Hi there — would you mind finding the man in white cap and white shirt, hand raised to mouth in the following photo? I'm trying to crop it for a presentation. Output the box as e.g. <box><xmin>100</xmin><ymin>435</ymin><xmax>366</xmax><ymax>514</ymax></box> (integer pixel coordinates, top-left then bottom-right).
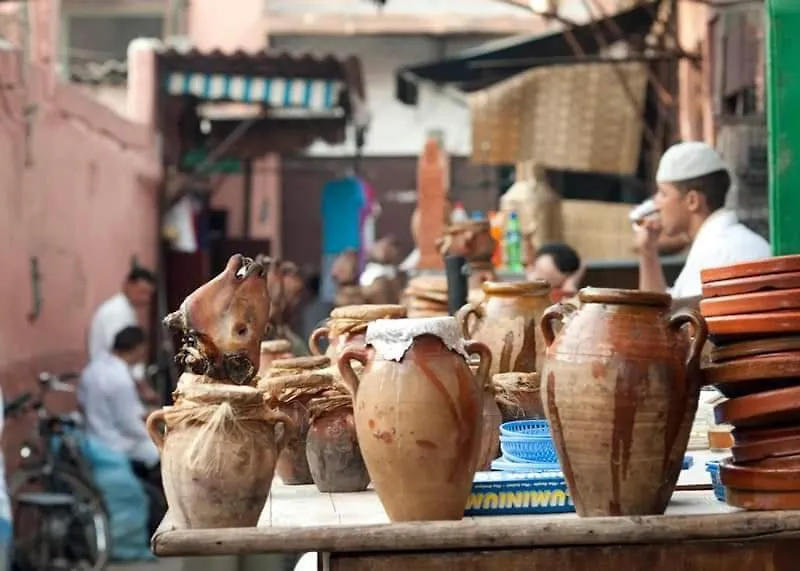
<box><xmin>636</xmin><ymin>141</ymin><xmax>772</xmax><ymax>302</ymax></box>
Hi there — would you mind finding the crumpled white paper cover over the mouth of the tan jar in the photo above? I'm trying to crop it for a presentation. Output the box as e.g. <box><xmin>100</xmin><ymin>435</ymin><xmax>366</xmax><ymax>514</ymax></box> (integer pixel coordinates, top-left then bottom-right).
<box><xmin>366</xmin><ymin>316</ymin><xmax>469</xmax><ymax>361</ymax></box>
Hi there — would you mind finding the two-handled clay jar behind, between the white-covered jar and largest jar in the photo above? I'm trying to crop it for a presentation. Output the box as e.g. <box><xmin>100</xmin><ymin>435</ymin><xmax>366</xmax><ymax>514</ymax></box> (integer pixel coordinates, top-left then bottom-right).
<box><xmin>456</xmin><ymin>281</ymin><xmax>552</xmax><ymax>375</ymax></box>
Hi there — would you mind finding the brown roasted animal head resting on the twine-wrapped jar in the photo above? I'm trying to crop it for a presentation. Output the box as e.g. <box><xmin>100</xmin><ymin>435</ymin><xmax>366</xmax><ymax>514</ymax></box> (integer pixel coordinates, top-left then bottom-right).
<box><xmin>164</xmin><ymin>254</ymin><xmax>276</xmax><ymax>385</ymax></box>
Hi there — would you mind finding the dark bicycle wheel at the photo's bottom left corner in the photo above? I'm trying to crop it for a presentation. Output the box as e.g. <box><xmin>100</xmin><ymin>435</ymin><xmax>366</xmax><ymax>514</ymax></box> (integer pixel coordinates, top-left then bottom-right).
<box><xmin>9</xmin><ymin>470</ymin><xmax>111</xmax><ymax>571</ymax></box>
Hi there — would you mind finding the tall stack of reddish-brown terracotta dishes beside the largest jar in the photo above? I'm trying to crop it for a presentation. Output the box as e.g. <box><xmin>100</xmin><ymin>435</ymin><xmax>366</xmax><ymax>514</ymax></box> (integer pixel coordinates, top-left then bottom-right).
<box><xmin>700</xmin><ymin>256</ymin><xmax>800</xmax><ymax>509</ymax></box>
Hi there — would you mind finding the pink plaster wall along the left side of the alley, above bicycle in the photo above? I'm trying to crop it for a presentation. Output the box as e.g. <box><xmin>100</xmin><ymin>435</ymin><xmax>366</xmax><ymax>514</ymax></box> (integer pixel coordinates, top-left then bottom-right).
<box><xmin>0</xmin><ymin>51</ymin><xmax>159</xmax><ymax>465</ymax></box>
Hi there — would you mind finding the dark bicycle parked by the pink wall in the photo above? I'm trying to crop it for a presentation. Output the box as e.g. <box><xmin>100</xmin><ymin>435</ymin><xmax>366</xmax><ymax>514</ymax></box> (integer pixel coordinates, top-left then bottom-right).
<box><xmin>4</xmin><ymin>373</ymin><xmax>111</xmax><ymax>571</ymax></box>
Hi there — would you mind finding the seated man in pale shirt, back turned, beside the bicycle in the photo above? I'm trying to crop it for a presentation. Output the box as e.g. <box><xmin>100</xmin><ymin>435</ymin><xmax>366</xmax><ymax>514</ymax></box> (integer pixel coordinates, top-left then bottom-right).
<box><xmin>78</xmin><ymin>326</ymin><xmax>164</xmax><ymax>532</ymax></box>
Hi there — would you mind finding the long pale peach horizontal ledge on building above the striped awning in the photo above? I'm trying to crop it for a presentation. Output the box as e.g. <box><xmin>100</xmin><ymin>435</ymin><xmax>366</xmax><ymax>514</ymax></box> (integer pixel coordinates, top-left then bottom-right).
<box><xmin>264</xmin><ymin>12</ymin><xmax>549</xmax><ymax>36</ymax></box>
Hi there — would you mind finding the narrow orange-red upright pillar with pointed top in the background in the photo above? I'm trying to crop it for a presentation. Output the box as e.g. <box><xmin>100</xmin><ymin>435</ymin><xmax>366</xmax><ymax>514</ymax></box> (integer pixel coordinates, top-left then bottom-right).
<box><xmin>417</xmin><ymin>133</ymin><xmax>450</xmax><ymax>270</ymax></box>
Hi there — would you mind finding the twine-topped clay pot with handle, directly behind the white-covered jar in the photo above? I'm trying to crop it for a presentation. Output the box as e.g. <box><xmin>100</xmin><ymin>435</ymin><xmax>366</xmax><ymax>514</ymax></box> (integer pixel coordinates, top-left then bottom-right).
<box><xmin>308</xmin><ymin>305</ymin><xmax>406</xmax><ymax>360</ymax></box>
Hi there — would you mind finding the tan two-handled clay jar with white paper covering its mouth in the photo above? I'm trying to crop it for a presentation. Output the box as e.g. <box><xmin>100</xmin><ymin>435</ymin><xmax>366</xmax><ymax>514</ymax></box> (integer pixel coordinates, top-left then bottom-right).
<box><xmin>339</xmin><ymin>317</ymin><xmax>491</xmax><ymax>521</ymax></box>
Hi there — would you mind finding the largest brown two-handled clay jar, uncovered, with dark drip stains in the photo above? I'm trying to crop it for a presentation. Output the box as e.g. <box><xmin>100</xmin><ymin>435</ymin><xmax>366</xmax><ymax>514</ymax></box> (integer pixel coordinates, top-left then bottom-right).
<box><xmin>541</xmin><ymin>288</ymin><xmax>707</xmax><ymax>516</ymax></box>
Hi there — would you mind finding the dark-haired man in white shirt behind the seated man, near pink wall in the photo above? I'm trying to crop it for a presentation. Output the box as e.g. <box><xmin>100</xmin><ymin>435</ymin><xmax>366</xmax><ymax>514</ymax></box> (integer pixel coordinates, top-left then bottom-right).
<box><xmin>89</xmin><ymin>268</ymin><xmax>156</xmax><ymax>361</ymax></box>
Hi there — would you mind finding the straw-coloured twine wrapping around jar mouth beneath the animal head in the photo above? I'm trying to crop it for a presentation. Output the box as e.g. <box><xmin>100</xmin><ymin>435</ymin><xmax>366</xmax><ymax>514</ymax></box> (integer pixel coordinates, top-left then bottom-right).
<box><xmin>164</xmin><ymin>397</ymin><xmax>276</xmax><ymax>477</ymax></box>
